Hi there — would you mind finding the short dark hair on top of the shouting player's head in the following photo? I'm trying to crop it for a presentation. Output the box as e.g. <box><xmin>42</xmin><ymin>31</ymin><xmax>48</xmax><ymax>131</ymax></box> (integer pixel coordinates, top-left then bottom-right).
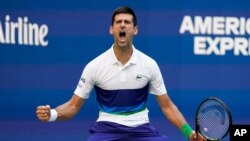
<box><xmin>111</xmin><ymin>6</ymin><xmax>137</xmax><ymax>26</ymax></box>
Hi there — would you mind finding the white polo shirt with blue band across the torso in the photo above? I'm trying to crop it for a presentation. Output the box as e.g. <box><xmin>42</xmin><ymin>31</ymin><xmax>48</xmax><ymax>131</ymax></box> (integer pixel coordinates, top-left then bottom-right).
<box><xmin>74</xmin><ymin>46</ymin><xmax>167</xmax><ymax>127</ymax></box>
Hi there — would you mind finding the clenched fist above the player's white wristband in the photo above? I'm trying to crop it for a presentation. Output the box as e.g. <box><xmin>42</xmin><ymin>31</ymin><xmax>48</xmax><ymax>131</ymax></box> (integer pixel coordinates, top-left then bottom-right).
<box><xmin>36</xmin><ymin>105</ymin><xmax>51</xmax><ymax>122</ymax></box>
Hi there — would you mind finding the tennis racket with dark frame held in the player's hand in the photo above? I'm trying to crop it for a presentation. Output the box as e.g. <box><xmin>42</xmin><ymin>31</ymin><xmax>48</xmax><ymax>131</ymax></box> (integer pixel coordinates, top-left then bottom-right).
<box><xmin>195</xmin><ymin>97</ymin><xmax>232</xmax><ymax>141</ymax></box>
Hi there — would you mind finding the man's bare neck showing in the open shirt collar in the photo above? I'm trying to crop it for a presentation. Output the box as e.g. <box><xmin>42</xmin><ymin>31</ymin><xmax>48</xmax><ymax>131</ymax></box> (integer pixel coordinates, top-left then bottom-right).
<box><xmin>113</xmin><ymin>45</ymin><xmax>133</xmax><ymax>65</ymax></box>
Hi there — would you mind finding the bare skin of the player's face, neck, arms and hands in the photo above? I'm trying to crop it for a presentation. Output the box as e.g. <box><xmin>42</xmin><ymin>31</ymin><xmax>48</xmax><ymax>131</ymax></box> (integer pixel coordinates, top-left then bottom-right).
<box><xmin>36</xmin><ymin>13</ymin><xmax>205</xmax><ymax>141</ymax></box>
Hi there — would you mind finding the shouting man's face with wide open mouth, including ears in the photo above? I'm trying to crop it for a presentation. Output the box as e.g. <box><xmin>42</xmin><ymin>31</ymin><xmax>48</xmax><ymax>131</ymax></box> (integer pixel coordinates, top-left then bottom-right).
<box><xmin>110</xmin><ymin>13</ymin><xmax>138</xmax><ymax>47</ymax></box>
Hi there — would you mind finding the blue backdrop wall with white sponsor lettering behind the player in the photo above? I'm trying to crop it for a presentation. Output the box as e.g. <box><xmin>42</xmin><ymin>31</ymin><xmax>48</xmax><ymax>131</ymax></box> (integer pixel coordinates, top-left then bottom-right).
<box><xmin>0</xmin><ymin>0</ymin><xmax>250</xmax><ymax>141</ymax></box>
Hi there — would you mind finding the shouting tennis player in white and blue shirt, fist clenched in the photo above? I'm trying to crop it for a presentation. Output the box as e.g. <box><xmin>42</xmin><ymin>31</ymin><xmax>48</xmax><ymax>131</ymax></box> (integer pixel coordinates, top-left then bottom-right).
<box><xmin>36</xmin><ymin>7</ymin><xmax>204</xmax><ymax>141</ymax></box>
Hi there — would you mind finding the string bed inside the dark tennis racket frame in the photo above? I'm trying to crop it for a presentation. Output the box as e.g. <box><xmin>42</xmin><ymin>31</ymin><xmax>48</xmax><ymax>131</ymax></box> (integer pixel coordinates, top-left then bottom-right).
<box><xmin>197</xmin><ymin>101</ymin><xmax>230</xmax><ymax>139</ymax></box>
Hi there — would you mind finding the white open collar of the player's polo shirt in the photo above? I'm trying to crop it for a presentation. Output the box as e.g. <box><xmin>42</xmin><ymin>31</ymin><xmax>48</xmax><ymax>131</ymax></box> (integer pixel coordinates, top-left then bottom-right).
<box><xmin>109</xmin><ymin>45</ymin><xmax>138</xmax><ymax>64</ymax></box>
